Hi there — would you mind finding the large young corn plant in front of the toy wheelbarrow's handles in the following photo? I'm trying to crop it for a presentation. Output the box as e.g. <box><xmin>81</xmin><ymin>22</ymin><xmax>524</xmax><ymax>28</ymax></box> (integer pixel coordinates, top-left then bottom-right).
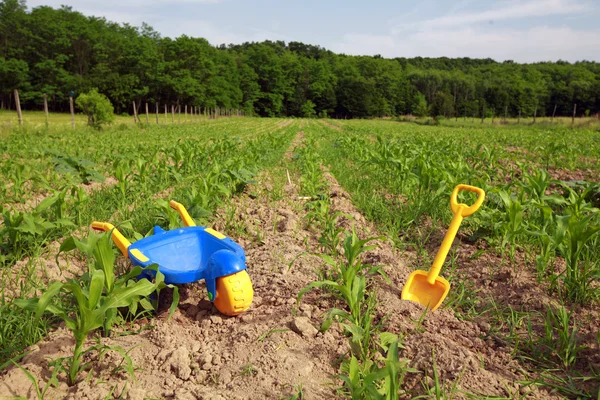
<box><xmin>16</xmin><ymin>234</ymin><xmax>179</xmax><ymax>385</ymax></box>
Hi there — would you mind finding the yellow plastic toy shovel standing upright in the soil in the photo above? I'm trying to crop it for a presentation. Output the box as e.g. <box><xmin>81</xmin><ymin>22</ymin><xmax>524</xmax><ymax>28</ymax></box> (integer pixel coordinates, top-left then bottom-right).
<box><xmin>402</xmin><ymin>185</ymin><xmax>485</xmax><ymax>311</ymax></box>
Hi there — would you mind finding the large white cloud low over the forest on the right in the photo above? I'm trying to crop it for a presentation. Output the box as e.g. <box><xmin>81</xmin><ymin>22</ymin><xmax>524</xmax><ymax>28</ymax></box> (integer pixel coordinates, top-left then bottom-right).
<box><xmin>332</xmin><ymin>0</ymin><xmax>600</xmax><ymax>62</ymax></box>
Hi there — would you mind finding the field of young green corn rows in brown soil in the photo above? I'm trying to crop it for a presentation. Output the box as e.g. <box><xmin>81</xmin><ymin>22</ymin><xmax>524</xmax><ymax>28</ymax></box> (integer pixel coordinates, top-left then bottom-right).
<box><xmin>0</xmin><ymin>113</ymin><xmax>600</xmax><ymax>399</ymax></box>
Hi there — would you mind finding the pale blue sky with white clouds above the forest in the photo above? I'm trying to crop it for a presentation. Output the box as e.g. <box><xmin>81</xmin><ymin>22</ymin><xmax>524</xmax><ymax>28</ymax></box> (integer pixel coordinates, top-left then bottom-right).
<box><xmin>27</xmin><ymin>0</ymin><xmax>600</xmax><ymax>62</ymax></box>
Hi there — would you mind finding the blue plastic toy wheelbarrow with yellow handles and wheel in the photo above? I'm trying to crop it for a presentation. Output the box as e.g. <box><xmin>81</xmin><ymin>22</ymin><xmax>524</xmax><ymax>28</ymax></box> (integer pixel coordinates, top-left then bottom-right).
<box><xmin>92</xmin><ymin>200</ymin><xmax>254</xmax><ymax>316</ymax></box>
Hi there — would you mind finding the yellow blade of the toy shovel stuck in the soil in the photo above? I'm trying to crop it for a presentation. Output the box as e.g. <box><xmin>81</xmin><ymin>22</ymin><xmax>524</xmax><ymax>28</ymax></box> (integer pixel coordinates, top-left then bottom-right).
<box><xmin>402</xmin><ymin>270</ymin><xmax>450</xmax><ymax>311</ymax></box>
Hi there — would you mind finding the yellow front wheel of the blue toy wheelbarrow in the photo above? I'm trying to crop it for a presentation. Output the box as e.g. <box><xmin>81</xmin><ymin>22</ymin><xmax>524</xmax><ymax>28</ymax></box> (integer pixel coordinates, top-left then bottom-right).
<box><xmin>214</xmin><ymin>270</ymin><xmax>254</xmax><ymax>317</ymax></box>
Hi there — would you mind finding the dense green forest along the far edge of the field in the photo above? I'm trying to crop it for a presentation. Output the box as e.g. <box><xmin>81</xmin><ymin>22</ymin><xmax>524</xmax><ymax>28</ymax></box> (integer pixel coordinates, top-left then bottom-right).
<box><xmin>0</xmin><ymin>0</ymin><xmax>600</xmax><ymax>118</ymax></box>
